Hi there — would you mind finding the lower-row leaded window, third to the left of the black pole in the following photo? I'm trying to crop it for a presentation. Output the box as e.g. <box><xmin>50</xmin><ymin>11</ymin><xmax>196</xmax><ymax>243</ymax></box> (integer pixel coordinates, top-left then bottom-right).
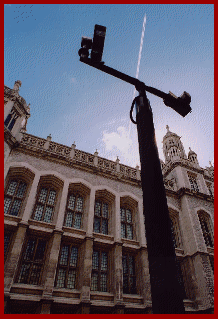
<box><xmin>56</xmin><ymin>244</ymin><xmax>78</xmax><ymax>289</ymax></box>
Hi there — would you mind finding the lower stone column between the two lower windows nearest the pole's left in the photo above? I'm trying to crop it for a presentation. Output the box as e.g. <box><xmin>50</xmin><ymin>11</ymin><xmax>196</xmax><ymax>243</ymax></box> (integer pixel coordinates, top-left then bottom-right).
<box><xmin>112</xmin><ymin>242</ymin><xmax>123</xmax><ymax>308</ymax></box>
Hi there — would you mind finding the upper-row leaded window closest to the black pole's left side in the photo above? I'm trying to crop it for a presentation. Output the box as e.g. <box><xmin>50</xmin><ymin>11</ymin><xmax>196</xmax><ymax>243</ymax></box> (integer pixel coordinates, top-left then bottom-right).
<box><xmin>120</xmin><ymin>207</ymin><xmax>133</xmax><ymax>239</ymax></box>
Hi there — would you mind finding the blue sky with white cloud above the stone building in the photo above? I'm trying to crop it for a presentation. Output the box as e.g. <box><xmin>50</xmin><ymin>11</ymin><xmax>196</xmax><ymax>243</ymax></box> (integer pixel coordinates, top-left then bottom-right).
<box><xmin>4</xmin><ymin>4</ymin><xmax>214</xmax><ymax>167</ymax></box>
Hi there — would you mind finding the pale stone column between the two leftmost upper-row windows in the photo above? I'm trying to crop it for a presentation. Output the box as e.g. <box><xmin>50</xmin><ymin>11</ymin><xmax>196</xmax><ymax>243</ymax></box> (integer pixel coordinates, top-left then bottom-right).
<box><xmin>22</xmin><ymin>172</ymin><xmax>40</xmax><ymax>222</ymax></box>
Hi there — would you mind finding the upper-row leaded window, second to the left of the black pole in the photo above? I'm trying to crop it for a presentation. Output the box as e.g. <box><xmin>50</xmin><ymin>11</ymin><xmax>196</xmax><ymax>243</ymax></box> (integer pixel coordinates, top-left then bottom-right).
<box><xmin>94</xmin><ymin>201</ymin><xmax>109</xmax><ymax>235</ymax></box>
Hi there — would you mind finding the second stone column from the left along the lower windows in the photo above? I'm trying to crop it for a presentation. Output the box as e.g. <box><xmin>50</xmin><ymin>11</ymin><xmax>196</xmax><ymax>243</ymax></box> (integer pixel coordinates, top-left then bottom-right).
<box><xmin>42</xmin><ymin>229</ymin><xmax>63</xmax><ymax>304</ymax></box>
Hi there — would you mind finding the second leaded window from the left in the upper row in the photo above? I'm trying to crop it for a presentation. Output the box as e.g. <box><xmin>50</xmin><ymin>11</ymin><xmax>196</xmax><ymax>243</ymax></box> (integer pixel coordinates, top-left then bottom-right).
<box><xmin>33</xmin><ymin>187</ymin><xmax>57</xmax><ymax>223</ymax></box>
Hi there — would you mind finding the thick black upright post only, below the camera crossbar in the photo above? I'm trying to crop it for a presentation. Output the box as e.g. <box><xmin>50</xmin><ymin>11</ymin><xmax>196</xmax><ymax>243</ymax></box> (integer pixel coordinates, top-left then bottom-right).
<box><xmin>136</xmin><ymin>90</ymin><xmax>185</xmax><ymax>314</ymax></box>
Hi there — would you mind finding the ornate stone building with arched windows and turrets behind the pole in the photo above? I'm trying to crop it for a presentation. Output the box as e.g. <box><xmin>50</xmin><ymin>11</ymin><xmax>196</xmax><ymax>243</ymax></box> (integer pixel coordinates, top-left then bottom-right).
<box><xmin>4</xmin><ymin>81</ymin><xmax>214</xmax><ymax>314</ymax></box>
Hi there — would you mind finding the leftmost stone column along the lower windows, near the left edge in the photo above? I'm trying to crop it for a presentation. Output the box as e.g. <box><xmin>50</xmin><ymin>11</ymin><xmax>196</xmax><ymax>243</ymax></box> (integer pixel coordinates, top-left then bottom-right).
<box><xmin>4</xmin><ymin>222</ymin><xmax>28</xmax><ymax>294</ymax></box>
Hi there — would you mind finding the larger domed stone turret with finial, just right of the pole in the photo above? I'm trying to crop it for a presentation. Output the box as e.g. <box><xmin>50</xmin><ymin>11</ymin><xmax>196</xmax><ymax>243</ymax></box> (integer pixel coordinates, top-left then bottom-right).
<box><xmin>163</xmin><ymin>125</ymin><xmax>187</xmax><ymax>164</ymax></box>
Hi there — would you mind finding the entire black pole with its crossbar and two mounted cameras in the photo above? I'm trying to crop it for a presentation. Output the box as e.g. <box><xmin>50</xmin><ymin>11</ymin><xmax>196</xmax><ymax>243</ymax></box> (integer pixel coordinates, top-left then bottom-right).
<box><xmin>79</xmin><ymin>25</ymin><xmax>191</xmax><ymax>314</ymax></box>
